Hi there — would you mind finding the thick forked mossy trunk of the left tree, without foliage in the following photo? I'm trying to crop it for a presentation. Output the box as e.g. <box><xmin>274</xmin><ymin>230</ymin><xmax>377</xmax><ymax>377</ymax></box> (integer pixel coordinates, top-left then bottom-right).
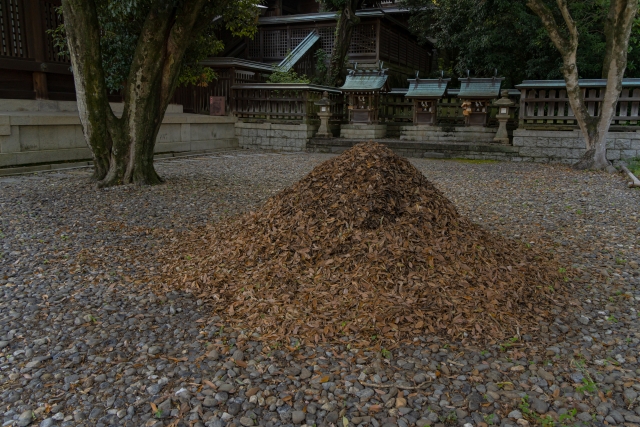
<box><xmin>62</xmin><ymin>0</ymin><xmax>211</xmax><ymax>187</ymax></box>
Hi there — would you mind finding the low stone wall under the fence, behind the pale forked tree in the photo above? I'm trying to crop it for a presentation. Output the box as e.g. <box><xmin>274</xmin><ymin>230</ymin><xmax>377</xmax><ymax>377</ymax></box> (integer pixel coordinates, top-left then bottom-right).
<box><xmin>513</xmin><ymin>129</ymin><xmax>640</xmax><ymax>163</ymax></box>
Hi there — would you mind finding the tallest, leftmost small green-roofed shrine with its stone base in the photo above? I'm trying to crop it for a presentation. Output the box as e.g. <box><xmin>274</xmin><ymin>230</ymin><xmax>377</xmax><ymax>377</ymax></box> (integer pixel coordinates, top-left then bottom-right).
<box><xmin>339</xmin><ymin>63</ymin><xmax>389</xmax><ymax>138</ymax></box>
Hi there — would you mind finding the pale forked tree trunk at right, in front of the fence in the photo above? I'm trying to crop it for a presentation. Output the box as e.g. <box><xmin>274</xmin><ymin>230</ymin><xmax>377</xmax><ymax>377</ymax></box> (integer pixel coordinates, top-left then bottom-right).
<box><xmin>527</xmin><ymin>0</ymin><xmax>638</xmax><ymax>169</ymax></box>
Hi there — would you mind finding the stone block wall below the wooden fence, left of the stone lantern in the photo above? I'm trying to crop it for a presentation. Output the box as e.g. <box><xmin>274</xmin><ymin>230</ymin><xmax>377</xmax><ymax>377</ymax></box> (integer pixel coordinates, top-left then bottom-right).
<box><xmin>236</xmin><ymin>122</ymin><xmax>319</xmax><ymax>151</ymax></box>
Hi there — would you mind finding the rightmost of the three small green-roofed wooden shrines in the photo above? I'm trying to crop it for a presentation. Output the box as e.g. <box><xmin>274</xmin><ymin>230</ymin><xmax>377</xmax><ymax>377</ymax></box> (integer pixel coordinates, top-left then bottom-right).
<box><xmin>458</xmin><ymin>77</ymin><xmax>504</xmax><ymax>126</ymax></box>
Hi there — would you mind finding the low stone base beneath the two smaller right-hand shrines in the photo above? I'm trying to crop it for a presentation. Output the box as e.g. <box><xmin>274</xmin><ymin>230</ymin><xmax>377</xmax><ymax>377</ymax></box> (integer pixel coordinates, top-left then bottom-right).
<box><xmin>400</xmin><ymin>125</ymin><xmax>498</xmax><ymax>144</ymax></box>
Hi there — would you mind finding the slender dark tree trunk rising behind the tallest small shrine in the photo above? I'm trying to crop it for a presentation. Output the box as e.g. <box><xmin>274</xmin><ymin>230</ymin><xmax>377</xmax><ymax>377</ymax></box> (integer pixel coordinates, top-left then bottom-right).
<box><xmin>325</xmin><ymin>0</ymin><xmax>364</xmax><ymax>86</ymax></box>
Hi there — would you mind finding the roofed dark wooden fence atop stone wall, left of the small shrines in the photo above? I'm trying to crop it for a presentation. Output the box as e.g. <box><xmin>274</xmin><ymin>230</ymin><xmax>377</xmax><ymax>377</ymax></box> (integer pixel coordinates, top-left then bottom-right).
<box><xmin>231</xmin><ymin>83</ymin><xmax>345</xmax><ymax>124</ymax></box>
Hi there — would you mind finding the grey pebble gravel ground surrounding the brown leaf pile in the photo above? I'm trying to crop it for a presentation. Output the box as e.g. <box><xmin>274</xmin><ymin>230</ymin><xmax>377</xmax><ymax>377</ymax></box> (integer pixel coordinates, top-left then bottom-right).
<box><xmin>0</xmin><ymin>152</ymin><xmax>640</xmax><ymax>427</ymax></box>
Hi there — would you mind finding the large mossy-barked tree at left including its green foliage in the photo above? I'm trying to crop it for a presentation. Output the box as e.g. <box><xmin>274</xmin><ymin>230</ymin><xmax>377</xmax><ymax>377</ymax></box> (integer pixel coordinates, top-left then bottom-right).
<box><xmin>57</xmin><ymin>0</ymin><xmax>259</xmax><ymax>187</ymax></box>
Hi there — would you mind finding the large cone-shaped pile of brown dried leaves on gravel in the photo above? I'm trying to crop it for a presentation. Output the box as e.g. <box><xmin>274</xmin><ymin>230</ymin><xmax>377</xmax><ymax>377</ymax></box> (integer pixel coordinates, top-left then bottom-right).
<box><xmin>158</xmin><ymin>142</ymin><xmax>564</xmax><ymax>344</ymax></box>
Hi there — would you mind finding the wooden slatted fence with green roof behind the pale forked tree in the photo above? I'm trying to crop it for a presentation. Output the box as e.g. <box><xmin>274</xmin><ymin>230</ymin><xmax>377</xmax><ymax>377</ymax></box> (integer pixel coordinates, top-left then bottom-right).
<box><xmin>516</xmin><ymin>79</ymin><xmax>640</xmax><ymax>129</ymax></box>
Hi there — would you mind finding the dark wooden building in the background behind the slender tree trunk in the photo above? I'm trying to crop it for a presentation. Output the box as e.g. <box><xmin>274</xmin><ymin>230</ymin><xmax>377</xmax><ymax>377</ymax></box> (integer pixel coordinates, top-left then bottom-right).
<box><xmin>242</xmin><ymin>0</ymin><xmax>436</xmax><ymax>87</ymax></box>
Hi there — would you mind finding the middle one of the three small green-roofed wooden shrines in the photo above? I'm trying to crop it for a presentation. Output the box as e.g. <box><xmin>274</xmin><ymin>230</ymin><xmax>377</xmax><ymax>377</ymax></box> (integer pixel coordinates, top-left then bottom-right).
<box><xmin>405</xmin><ymin>73</ymin><xmax>451</xmax><ymax>126</ymax></box>
